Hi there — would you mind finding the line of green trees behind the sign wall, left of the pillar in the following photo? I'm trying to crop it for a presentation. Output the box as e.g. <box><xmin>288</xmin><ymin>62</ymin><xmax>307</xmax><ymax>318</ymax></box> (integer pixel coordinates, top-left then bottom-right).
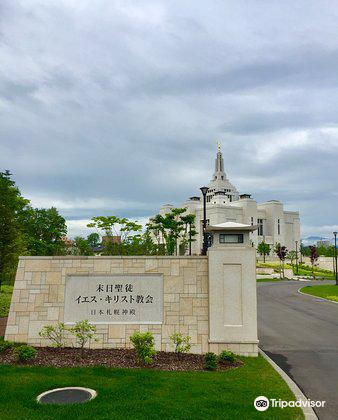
<box><xmin>0</xmin><ymin>171</ymin><xmax>197</xmax><ymax>284</ymax></box>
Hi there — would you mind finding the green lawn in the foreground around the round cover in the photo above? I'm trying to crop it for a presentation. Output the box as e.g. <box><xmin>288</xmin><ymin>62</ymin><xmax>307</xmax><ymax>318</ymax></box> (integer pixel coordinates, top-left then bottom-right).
<box><xmin>0</xmin><ymin>357</ymin><xmax>304</xmax><ymax>420</ymax></box>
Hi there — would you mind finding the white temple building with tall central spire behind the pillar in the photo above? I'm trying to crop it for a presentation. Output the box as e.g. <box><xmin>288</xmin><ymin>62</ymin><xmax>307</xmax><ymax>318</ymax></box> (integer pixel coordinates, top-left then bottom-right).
<box><xmin>160</xmin><ymin>145</ymin><xmax>300</xmax><ymax>254</ymax></box>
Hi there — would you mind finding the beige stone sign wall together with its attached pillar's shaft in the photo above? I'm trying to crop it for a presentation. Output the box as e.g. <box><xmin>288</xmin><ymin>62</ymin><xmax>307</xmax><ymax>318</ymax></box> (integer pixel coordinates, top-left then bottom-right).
<box><xmin>5</xmin><ymin>249</ymin><xmax>258</xmax><ymax>356</ymax></box>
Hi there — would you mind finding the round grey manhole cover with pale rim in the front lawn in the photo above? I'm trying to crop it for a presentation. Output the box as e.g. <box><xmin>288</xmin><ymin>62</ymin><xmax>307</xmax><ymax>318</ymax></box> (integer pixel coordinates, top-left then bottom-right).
<box><xmin>37</xmin><ymin>386</ymin><xmax>96</xmax><ymax>404</ymax></box>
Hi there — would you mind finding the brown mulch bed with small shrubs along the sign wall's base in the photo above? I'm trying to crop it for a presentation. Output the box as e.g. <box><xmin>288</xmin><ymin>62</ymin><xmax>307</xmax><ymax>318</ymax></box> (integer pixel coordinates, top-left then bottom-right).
<box><xmin>0</xmin><ymin>347</ymin><xmax>243</xmax><ymax>371</ymax></box>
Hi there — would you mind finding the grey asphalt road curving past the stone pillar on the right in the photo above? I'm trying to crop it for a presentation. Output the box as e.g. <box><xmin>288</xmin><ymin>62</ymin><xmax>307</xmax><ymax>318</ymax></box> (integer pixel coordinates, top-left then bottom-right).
<box><xmin>257</xmin><ymin>281</ymin><xmax>338</xmax><ymax>420</ymax></box>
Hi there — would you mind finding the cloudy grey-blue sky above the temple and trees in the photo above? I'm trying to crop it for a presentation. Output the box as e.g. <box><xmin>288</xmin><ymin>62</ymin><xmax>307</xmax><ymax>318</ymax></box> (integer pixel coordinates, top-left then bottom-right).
<box><xmin>0</xmin><ymin>0</ymin><xmax>338</xmax><ymax>237</ymax></box>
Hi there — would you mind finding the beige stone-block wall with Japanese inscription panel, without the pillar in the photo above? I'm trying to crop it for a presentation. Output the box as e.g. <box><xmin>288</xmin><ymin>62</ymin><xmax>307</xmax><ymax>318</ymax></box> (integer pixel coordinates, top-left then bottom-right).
<box><xmin>6</xmin><ymin>256</ymin><xmax>209</xmax><ymax>353</ymax></box>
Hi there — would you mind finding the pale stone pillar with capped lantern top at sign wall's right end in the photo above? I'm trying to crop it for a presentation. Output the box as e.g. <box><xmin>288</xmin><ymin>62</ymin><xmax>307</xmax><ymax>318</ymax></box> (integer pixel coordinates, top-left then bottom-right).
<box><xmin>207</xmin><ymin>222</ymin><xmax>258</xmax><ymax>356</ymax></box>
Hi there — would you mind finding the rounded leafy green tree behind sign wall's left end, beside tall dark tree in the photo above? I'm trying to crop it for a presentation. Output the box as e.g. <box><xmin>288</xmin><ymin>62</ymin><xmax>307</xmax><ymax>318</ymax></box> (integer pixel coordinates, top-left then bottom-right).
<box><xmin>20</xmin><ymin>206</ymin><xmax>67</xmax><ymax>255</ymax></box>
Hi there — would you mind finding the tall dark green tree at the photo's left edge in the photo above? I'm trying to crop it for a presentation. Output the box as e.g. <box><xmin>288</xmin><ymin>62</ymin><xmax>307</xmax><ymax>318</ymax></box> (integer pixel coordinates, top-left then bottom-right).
<box><xmin>0</xmin><ymin>171</ymin><xmax>29</xmax><ymax>290</ymax></box>
